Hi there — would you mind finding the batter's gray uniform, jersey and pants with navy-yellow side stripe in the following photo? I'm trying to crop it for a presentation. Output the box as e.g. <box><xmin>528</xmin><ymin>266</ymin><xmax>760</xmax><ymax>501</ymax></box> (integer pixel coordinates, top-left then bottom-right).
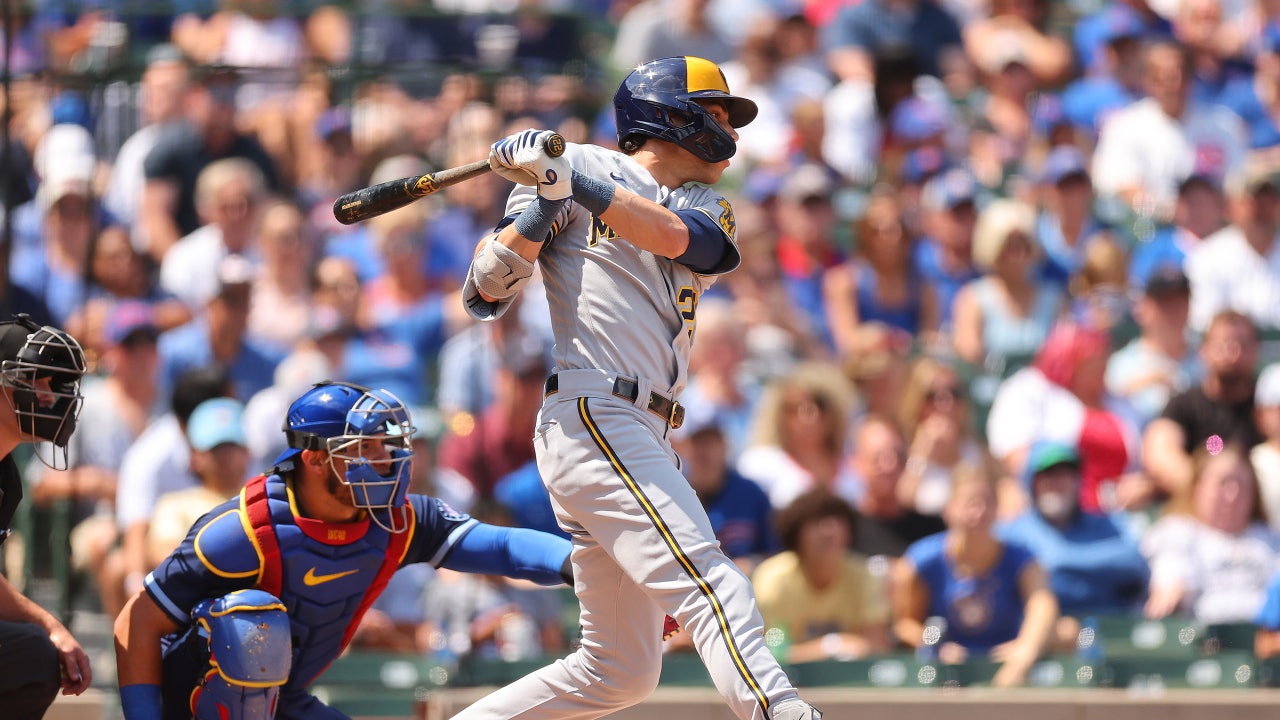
<box><xmin>456</xmin><ymin>145</ymin><xmax>795</xmax><ymax>720</ymax></box>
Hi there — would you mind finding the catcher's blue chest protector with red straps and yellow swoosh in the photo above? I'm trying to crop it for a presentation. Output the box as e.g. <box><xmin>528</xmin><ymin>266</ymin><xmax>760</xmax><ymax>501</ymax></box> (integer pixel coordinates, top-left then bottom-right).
<box><xmin>241</xmin><ymin>475</ymin><xmax>416</xmax><ymax>688</ymax></box>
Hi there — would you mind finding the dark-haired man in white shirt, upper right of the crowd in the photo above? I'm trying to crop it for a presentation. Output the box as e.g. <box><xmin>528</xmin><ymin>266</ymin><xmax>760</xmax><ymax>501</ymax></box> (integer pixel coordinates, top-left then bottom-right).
<box><xmin>1092</xmin><ymin>42</ymin><xmax>1248</xmax><ymax>219</ymax></box>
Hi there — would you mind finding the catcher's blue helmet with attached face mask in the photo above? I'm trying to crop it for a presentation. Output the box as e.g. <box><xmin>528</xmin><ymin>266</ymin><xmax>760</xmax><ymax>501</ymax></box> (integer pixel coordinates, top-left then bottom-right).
<box><xmin>275</xmin><ymin>382</ymin><xmax>413</xmax><ymax>533</ymax></box>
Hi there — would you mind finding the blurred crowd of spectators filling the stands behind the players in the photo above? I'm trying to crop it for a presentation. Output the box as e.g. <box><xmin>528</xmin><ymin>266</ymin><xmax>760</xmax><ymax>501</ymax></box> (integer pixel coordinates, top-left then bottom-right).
<box><xmin>12</xmin><ymin>0</ymin><xmax>1280</xmax><ymax>683</ymax></box>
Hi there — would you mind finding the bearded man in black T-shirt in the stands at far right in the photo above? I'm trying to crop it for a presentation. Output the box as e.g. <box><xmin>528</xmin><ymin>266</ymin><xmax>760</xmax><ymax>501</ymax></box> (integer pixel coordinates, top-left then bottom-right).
<box><xmin>1142</xmin><ymin>308</ymin><xmax>1263</xmax><ymax>496</ymax></box>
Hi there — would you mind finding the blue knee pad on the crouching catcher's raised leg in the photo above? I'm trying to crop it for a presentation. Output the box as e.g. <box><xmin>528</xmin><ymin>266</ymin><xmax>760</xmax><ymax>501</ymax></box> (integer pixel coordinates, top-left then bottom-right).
<box><xmin>191</xmin><ymin>589</ymin><xmax>293</xmax><ymax>720</ymax></box>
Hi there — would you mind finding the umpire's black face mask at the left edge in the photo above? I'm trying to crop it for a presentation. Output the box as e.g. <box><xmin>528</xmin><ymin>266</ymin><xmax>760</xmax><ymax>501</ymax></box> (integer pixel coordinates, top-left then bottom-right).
<box><xmin>0</xmin><ymin>315</ymin><xmax>86</xmax><ymax>470</ymax></box>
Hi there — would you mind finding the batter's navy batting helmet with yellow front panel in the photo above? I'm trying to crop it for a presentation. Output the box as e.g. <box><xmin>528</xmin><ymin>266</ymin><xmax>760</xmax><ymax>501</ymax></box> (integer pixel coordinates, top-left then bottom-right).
<box><xmin>613</xmin><ymin>55</ymin><xmax>756</xmax><ymax>163</ymax></box>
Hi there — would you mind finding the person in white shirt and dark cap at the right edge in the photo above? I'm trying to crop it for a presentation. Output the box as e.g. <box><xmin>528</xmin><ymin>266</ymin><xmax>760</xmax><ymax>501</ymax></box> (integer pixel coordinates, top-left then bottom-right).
<box><xmin>1184</xmin><ymin>166</ymin><xmax>1280</xmax><ymax>332</ymax></box>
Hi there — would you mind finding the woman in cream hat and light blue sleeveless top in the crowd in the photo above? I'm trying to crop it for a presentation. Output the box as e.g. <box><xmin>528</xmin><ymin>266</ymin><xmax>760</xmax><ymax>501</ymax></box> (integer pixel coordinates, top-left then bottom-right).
<box><xmin>951</xmin><ymin>200</ymin><xmax>1064</xmax><ymax>364</ymax></box>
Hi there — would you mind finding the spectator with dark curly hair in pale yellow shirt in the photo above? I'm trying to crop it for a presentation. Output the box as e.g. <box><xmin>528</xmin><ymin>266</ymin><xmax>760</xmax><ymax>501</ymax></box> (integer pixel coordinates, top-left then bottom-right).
<box><xmin>751</xmin><ymin>488</ymin><xmax>890</xmax><ymax>662</ymax></box>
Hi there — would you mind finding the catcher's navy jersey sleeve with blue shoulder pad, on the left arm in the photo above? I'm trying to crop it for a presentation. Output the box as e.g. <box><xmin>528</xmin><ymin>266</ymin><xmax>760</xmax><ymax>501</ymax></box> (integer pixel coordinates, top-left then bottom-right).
<box><xmin>145</xmin><ymin>498</ymin><xmax>262</xmax><ymax>625</ymax></box>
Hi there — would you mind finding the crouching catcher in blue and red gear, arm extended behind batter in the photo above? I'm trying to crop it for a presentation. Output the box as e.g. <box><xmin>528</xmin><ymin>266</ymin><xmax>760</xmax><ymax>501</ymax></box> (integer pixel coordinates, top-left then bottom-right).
<box><xmin>115</xmin><ymin>382</ymin><xmax>572</xmax><ymax>720</ymax></box>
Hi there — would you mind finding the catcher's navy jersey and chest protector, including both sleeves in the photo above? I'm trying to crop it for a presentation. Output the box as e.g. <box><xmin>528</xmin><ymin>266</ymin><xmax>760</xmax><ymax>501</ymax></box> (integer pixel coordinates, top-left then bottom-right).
<box><xmin>146</xmin><ymin>475</ymin><xmax>476</xmax><ymax>691</ymax></box>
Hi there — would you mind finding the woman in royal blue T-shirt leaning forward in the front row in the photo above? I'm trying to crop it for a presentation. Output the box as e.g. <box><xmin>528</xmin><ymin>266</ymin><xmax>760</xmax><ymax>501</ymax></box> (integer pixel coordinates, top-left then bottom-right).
<box><xmin>892</xmin><ymin>468</ymin><xmax>1059</xmax><ymax>687</ymax></box>
